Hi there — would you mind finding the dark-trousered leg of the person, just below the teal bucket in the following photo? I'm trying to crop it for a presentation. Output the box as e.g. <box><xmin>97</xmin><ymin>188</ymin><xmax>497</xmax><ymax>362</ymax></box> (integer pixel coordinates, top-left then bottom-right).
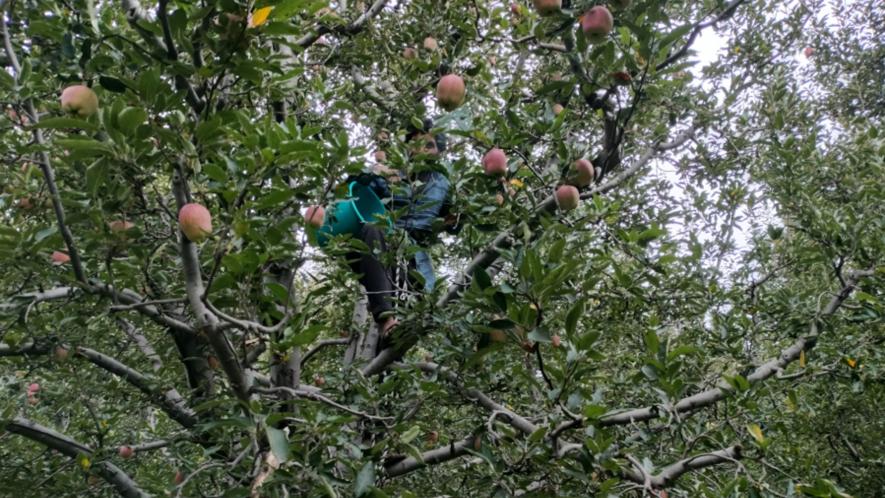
<box><xmin>348</xmin><ymin>224</ymin><xmax>396</xmax><ymax>332</ymax></box>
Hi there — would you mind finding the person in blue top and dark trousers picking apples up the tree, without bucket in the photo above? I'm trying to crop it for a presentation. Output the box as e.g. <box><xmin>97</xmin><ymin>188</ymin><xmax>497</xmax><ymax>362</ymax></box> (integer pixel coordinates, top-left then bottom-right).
<box><xmin>348</xmin><ymin>119</ymin><xmax>460</xmax><ymax>337</ymax></box>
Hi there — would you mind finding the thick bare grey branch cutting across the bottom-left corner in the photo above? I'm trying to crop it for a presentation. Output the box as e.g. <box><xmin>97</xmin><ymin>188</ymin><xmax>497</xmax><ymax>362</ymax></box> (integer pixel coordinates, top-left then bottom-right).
<box><xmin>0</xmin><ymin>417</ymin><xmax>151</xmax><ymax>498</ymax></box>
